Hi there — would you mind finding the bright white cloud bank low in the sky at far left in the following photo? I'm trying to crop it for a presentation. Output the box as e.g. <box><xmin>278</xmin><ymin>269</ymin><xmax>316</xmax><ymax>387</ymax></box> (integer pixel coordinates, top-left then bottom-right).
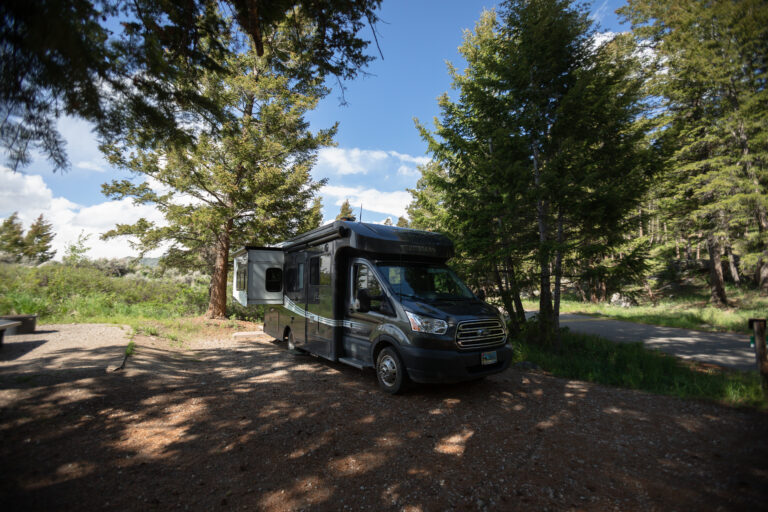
<box><xmin>0</xmin><ymin>167</ymin><xmax>163</xmax><ymax>260</ymax></box>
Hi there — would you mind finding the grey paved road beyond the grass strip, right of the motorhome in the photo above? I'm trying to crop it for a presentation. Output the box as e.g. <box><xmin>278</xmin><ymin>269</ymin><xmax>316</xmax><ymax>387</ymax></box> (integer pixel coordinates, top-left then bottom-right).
<box><xmin>544</xmin><ymin>314</ymin><xmax>757</xmax><ymax>370</ymax></box>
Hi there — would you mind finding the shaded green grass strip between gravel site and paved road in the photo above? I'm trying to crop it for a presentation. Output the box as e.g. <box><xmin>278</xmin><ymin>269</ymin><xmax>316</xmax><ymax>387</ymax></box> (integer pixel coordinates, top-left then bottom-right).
<box><xmin>517</xmin><ymin>329</ymin><xmax>768</xmax><ymax>408</ymax></box>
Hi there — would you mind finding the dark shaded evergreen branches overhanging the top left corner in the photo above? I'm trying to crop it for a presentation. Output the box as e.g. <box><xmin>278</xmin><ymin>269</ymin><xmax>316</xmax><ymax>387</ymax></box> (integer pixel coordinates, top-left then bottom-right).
<box><xmin>0</xmin><ymin>0</ymin><xmax>381</xmax><ymax>169</ymax></box>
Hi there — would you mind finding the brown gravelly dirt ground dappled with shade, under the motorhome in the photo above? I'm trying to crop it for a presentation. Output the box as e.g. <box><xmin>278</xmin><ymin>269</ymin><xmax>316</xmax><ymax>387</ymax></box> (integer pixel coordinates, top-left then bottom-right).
<box><xmin>0</xmin><ymin>325</ymin><xmax>768</xmax><ymax>511</ymax></box>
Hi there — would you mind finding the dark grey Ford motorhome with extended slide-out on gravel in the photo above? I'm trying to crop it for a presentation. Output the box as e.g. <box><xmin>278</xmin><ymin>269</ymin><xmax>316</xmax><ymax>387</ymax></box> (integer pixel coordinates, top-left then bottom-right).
<box><xmin>233</xmin><ymin>220</ymin><xmax>512</xmax><ymax>393</ymax></box>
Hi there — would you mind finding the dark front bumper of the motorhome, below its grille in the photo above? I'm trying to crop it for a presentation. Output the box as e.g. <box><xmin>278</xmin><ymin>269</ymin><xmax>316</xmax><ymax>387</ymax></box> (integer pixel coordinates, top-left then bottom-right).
<box><xmin>399</xmin><ymin>344</ymin><xmax>512</xmax><ymax>383</ymax></box>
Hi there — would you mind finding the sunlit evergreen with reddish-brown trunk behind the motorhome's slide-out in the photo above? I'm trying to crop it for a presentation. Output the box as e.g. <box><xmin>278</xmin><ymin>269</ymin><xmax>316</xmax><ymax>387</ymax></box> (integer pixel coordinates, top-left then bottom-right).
<box><xmin>103</xmin><ymin>16</ymin><xmax>335</xmax><ymax>317</ymax></box>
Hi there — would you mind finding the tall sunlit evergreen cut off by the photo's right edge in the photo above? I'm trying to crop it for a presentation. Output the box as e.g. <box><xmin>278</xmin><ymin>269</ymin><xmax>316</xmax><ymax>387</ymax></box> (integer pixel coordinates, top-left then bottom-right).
<box><xmin>622</xmin><ymin>0</ymin><xmax>768</xmax><ymax>296</ymax></box>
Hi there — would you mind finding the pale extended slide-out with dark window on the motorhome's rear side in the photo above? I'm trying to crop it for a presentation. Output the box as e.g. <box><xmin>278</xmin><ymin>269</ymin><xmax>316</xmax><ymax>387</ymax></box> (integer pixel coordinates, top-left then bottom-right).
<box><xmin>232</xmin><ymin>248</ymin><xmax>284</xmax><ymax>306</ymax></box>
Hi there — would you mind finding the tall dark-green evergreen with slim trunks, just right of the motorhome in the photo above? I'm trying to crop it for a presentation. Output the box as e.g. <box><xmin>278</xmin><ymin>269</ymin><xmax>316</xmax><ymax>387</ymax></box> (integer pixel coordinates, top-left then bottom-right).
<box><xmin>409</xmin><ymin>0</ymin><xmax>648</xmax><ymax>343</ymax></box>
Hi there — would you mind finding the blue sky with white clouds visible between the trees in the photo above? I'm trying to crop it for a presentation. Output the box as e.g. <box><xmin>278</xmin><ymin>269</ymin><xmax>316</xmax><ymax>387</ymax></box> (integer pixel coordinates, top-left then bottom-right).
<box><xmin>0</xmin><ymin>0</ymin><xmax>627</xmax><ymax>259</ymax></box>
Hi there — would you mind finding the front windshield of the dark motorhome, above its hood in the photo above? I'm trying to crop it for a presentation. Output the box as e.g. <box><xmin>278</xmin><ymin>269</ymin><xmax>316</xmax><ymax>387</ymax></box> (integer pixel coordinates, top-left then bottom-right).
<box><xmin>378</xmin><ymin>263</ymin><xmax>475</xmax><ymax>301</ymax></box>
